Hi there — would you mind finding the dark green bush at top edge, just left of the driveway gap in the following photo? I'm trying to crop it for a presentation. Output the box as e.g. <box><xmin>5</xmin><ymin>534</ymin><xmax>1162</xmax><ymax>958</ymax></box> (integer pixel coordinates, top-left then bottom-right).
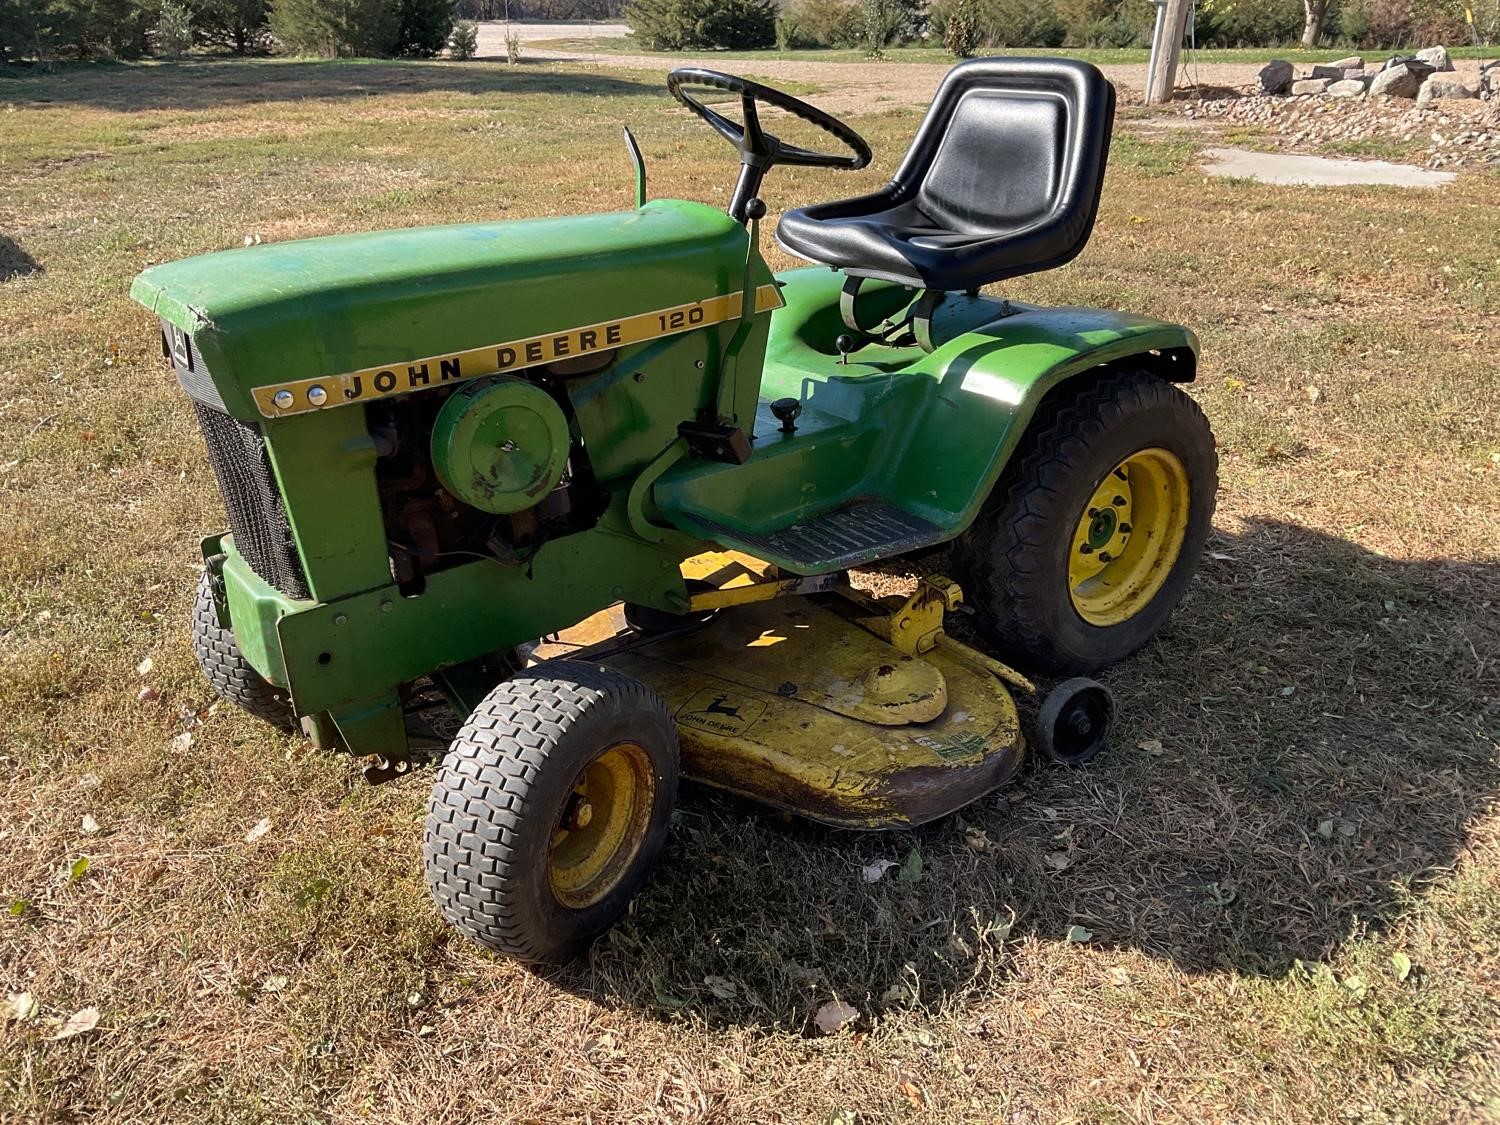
<box><xmin>272</xmin><ymin>0</ymin><xmax>453</xmax><ymax>59</ymax></box>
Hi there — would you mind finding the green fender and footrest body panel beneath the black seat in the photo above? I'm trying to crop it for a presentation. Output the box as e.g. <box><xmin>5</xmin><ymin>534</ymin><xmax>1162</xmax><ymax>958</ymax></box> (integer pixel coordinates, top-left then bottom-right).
<box><xmin>654</xmin><ymin>267</ymin><xmax>1197</xmax><ymax>573</ymax></box>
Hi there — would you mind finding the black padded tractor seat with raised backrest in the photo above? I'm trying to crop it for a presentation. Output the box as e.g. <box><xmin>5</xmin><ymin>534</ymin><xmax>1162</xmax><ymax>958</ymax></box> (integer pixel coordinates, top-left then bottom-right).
<box><xmin>776</xmin><ymin>59</ymin><xmax>1115</xmax><ymax>293</ymax></box>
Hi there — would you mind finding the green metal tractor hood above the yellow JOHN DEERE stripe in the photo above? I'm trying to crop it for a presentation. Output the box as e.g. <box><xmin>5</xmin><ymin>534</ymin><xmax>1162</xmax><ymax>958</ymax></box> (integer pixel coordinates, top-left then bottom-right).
<box><xmin>131</xmin><ymin>200</ymin><xmax>750</xmax><ymax>420</ymax></box>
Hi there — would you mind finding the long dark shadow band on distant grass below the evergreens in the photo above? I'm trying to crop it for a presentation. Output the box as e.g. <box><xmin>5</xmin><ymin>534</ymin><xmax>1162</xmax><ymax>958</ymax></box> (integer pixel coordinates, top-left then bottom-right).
<box><xmin>0</xmin><ymin>59</ymin><xmax>665</xmax><ymax>113</ymax></box>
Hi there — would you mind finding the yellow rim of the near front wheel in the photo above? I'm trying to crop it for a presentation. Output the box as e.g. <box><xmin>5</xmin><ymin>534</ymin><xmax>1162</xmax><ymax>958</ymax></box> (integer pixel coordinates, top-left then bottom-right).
<box><xmin>548</xmin><ymin>743</ymin><xmax>656</xmax><ymax>911</ymax></box>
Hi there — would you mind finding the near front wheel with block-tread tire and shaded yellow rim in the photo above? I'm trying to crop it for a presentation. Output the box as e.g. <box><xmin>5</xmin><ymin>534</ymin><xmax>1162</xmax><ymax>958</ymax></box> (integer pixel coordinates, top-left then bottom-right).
<box><xmin>423</xmin><ymin>660</ymin><xmax>678</xmax><ymax>965</ymax></box>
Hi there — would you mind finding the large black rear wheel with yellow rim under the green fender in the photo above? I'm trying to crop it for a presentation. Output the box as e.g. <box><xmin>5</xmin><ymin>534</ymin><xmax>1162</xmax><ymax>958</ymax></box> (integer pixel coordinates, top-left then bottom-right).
<box><xmin>954</xmin><ymin>372</ymin><xmax>1218</xmax><ymax>675</ymax></box>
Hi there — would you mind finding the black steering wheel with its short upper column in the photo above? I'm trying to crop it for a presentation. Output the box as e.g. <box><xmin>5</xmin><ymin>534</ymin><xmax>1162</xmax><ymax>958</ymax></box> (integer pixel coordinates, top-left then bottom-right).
<box><xmin>666</xmin><ymin>66</ymin><xmax>870</xmax><ymax>222</ymax></box>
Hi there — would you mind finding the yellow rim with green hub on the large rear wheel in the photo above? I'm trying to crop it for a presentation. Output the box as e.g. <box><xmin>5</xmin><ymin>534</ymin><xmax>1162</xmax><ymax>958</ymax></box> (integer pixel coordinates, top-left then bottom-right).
<box><xmin>1068</xmin><ymin>449</ymin><xmax>1190</xmax><ymax>627</ymax></box>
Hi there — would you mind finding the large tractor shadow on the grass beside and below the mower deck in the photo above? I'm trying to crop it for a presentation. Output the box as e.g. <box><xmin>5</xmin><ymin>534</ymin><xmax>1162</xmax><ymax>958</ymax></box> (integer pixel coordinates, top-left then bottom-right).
<box><xmin>557</xmin><ymin>521</ymin><xmax>1500</xmax><ymax>1026</ymax></box>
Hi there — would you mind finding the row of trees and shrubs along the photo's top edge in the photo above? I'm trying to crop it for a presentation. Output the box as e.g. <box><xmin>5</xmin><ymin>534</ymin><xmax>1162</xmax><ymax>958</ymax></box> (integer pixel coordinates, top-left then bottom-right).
<box><xmin>0</xmin><ymin>0</ymin><xmax>1500</xmax><ymax>62</ymax></box>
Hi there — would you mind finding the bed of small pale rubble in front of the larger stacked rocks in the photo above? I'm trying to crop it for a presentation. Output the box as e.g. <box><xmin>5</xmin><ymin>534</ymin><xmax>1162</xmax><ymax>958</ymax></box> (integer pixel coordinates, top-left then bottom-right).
<box><xmin>1182</xmin><ymin>92</ymin><xmax>1500</xmax><ymax>168</ymax></box>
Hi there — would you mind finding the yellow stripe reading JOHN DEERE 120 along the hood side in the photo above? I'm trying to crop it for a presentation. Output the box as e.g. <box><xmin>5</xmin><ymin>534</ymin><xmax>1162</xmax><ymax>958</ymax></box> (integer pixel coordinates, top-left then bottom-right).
<box><xmin>251</xmin><ymin>285</ymin><xmax>786</xmax><ymax>419</ymax></box>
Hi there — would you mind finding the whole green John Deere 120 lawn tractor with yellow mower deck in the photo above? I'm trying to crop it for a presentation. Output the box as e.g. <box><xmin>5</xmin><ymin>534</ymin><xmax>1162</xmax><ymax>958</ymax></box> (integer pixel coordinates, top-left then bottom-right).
<box><xmin>132</xmin><ymin>59</ymin><xmax>1217</xmax><ymax>963</ymax></box>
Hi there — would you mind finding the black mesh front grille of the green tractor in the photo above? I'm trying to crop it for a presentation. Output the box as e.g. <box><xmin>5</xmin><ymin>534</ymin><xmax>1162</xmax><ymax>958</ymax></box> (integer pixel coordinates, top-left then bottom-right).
<box><xmin>194</xmin><ymin>402</ymin><xmax>311</xmax><ymax>599</ymax></box>
